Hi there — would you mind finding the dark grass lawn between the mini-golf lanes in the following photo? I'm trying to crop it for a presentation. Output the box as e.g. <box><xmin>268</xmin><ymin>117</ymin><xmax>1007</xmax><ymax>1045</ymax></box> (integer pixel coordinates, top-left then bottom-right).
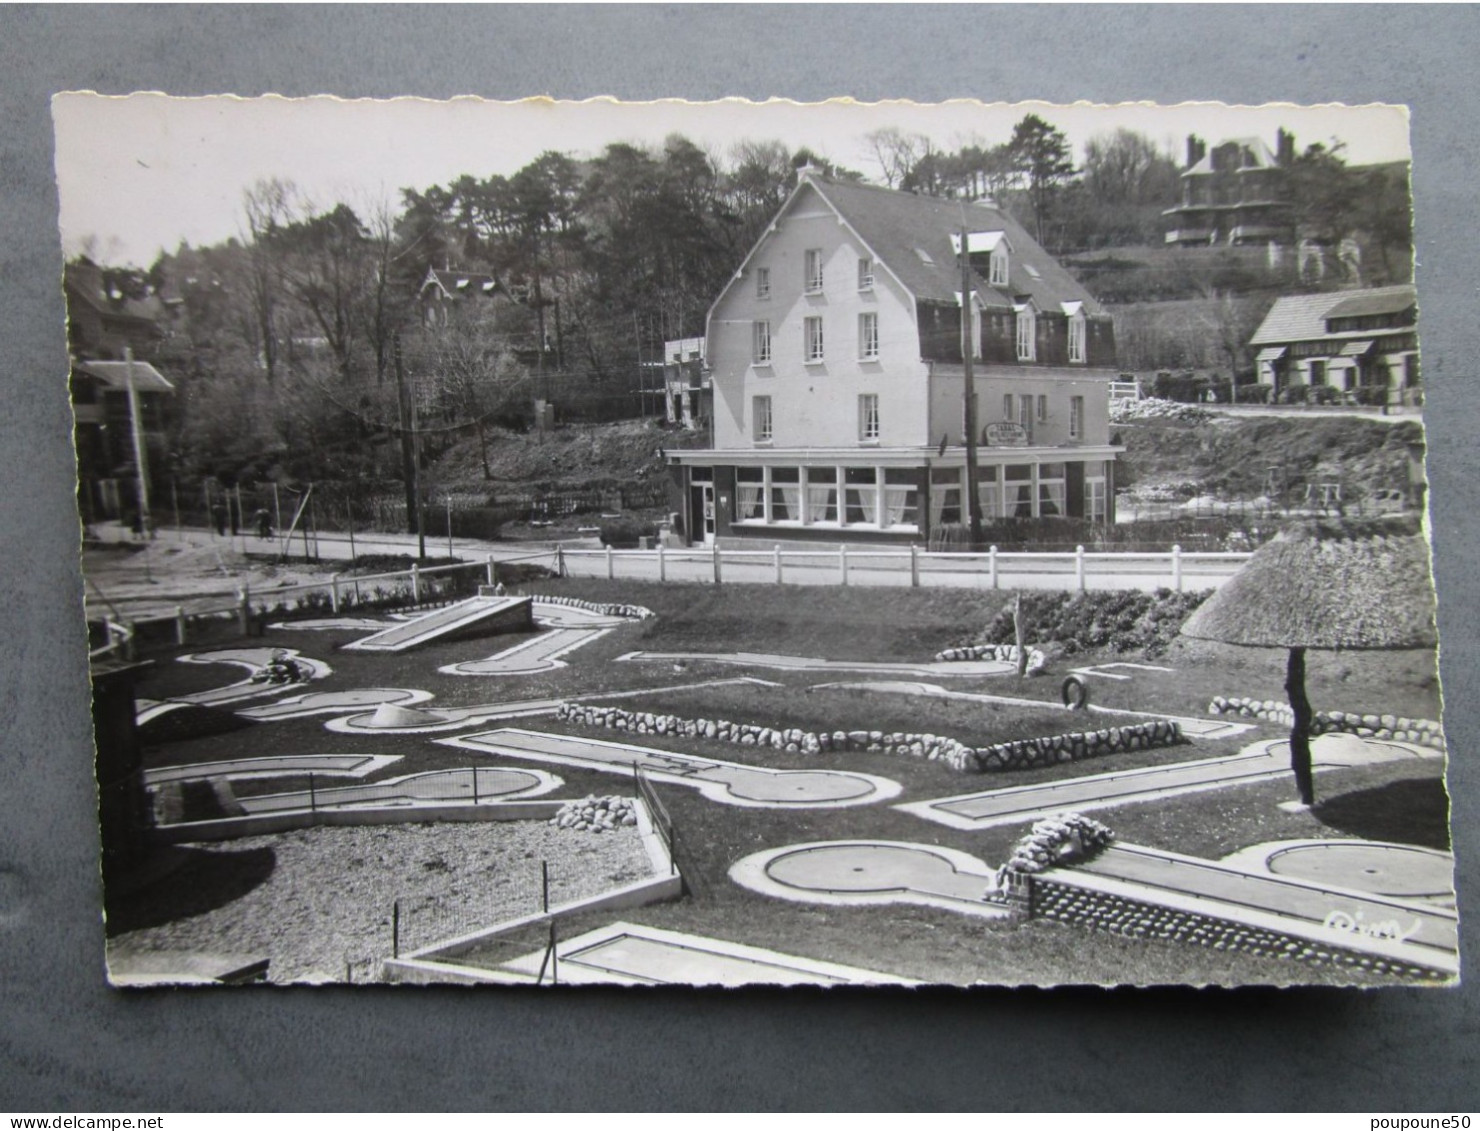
<box><xmin>110</xmin><ymin>580</ymin><xmax>1447</xmax><ymax>984</ymax></box>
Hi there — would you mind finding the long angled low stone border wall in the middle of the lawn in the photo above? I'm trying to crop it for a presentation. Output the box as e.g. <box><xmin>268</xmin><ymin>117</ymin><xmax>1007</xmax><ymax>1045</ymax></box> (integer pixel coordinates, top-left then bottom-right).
<box><xmin>555</xmin><ymin>703</ymin><xmax>1187</xmax><ymax>774</ymax></box>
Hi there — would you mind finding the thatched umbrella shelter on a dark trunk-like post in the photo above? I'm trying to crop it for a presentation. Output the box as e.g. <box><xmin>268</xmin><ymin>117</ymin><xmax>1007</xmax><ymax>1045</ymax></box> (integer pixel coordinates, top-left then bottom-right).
<box><xmin>1183</xmin><ymin>520</ymin><xmax>1437</xmax><ymax>805</ymax></box>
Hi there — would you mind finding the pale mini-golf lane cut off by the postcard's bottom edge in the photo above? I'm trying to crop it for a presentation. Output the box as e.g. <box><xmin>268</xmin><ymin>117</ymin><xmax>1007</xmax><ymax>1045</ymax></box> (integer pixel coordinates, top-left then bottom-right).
<box><xmin>500</xmin><ymin>922</ymin><xmax>919</xmax><ymax>987</ymax></box>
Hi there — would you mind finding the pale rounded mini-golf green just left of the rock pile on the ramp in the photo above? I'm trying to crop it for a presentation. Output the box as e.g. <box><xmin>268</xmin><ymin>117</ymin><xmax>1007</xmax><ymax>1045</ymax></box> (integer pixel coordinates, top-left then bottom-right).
<box><xmin>730</xmin><ymin>841</ymin><xmax>1009</xmax><ymax>919</ymax></box>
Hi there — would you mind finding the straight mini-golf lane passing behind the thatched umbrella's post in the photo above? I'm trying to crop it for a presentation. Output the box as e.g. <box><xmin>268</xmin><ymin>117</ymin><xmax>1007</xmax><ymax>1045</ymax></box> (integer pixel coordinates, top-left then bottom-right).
<box><xmin>895</xmin><ymin>734</ymin><xmax>1443</xmax><ymax>829</ymax></box>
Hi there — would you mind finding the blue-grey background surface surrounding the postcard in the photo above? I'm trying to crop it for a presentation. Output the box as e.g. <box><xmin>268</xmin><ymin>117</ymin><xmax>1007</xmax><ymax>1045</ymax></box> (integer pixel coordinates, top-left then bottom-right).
<box><xmin>0</xmin><ymin>4</ymin><xmax>1480</xmax><ymax>1112</ymax></box>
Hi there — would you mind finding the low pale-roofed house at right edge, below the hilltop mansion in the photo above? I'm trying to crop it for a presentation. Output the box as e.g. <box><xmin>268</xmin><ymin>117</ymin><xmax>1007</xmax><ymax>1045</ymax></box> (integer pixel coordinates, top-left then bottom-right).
<box><xmin>1249</xmin><ymin>284</ymin><xmax>1419</xmax><ymax>404</ymax></box>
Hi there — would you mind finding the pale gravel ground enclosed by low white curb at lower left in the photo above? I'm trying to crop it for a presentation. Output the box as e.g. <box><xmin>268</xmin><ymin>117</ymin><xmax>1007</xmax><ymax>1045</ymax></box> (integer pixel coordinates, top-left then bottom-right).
<box><xmin>108</xmin><ymin>820</ymin><xmax>651</xmax><ymax>981</ymax></box>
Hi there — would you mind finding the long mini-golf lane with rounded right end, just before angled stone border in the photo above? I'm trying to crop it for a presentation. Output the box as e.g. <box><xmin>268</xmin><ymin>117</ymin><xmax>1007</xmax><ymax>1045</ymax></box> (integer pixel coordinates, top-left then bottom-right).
<box><xmin>437</xmin><ymin>728</ymin><xmax>900</xmax><ymax>808</ymax></box>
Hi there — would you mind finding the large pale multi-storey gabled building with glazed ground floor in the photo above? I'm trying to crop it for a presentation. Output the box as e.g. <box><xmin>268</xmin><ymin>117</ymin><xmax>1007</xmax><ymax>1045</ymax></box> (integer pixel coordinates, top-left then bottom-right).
<box><xmin>667</xmin><ymin>167</ymin><xmax>1122</xmax><ymax>545</ymax></box>
